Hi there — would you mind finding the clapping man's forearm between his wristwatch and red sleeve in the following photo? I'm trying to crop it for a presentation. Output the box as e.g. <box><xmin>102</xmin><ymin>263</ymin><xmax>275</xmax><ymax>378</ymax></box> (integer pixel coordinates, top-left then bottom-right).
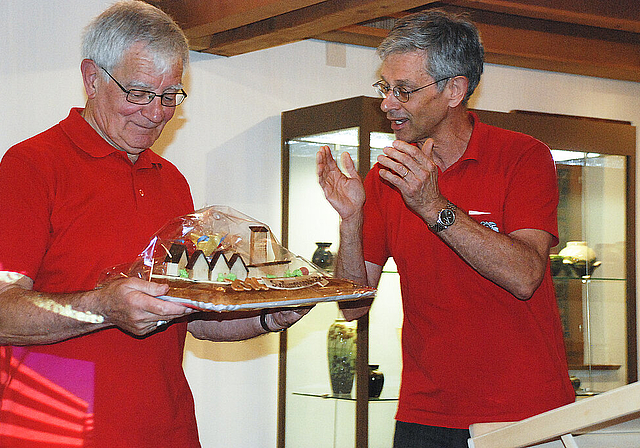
<box><xmin>438</xmin><ymin>210</ymin><xmax>552</xmax><ymax>300</ymax></box>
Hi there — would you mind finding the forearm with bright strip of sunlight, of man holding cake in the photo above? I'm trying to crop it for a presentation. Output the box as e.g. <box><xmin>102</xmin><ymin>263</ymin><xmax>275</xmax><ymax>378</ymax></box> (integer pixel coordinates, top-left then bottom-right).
<box><xmin>0</xmin><ymin>285</ymin><xmax>108</xmax><ymax>345</ymax></box>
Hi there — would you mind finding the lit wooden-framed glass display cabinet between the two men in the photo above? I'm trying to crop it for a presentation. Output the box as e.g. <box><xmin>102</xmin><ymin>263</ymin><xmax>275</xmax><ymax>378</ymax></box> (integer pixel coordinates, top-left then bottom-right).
<box><xmin>278</xmin><ymin>96</ymin><xmax>401</xmax><ymax>447</ymax></box>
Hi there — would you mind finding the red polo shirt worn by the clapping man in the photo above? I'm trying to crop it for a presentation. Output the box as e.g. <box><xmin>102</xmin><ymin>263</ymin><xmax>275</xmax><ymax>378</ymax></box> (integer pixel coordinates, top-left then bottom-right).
<box><xmin>364</xmin><ymin>114</ymin><xmax>574</xmax><ymax>428</ymax></box>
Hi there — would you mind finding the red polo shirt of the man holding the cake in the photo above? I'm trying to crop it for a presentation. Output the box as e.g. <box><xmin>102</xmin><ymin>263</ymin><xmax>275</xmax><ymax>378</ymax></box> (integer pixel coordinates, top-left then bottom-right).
<box><xmin>0</xmin><ymin>109</ymin><xmax>199</xmax><ymax>447</ymax></box>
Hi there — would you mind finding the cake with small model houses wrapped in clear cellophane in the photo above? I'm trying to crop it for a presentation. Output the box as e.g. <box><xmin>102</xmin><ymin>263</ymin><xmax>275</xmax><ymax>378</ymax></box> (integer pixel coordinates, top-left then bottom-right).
<box><xmin>101</xmin><ymin>206</ymin><xmax>375</xmax><ymax>311</ymax></box>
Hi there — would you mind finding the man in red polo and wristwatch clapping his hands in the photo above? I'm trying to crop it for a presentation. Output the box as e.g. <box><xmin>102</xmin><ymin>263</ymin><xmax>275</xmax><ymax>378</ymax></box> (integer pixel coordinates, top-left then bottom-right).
<box><xmin>317</xmin><ymin>11</ymin><xmax>574</xmax><ymax>448</ymax></box>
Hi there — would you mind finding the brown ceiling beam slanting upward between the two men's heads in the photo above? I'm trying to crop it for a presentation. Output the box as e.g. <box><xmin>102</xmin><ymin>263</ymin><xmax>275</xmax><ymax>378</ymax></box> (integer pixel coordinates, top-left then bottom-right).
<box><xmin>192</xmin><ymin>0</ymin><xmax>433</xmax><ymax>56</ymax></box>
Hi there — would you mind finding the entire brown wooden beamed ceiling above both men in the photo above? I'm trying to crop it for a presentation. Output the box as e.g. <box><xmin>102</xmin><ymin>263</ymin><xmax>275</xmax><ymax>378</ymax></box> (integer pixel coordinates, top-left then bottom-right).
<box><xmin>148</xmin><ymin>0</ymin><xmax>640</xmax><ymax>82</ymax></box>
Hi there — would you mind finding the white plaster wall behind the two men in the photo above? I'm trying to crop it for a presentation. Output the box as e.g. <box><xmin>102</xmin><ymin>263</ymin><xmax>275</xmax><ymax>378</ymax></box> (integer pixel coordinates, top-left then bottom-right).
<box><xmin>0</xmin><ymin>0</ymin><xmax>640</xmax><ymax>448</ymax></box>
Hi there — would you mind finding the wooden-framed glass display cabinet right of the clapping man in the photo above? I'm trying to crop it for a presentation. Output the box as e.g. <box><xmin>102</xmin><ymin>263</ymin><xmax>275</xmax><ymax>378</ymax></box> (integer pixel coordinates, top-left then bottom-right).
<box><xmin>478</xmin><ymin>111</ymin><xmax>638</xmax><ymax>397</ymax></box>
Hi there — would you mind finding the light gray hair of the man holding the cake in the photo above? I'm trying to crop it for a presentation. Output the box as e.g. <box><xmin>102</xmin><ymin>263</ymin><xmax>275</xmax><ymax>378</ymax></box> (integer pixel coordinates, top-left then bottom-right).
<box><xmin>82</xmin><ymin>0</ymin><xmax>189</xmax><ymax>76</ymax></box>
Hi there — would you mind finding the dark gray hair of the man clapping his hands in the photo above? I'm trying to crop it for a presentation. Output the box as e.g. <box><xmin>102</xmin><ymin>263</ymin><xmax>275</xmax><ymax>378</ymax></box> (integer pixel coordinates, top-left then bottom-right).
<box><xmin>378</xmin><ymin>10</ymin><xmax>484</xmax><ymax>104</ymax></box>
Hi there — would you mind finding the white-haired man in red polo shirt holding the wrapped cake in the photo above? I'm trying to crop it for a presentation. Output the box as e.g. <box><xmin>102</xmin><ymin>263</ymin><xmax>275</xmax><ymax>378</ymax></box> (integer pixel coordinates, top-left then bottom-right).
<box><xmin>0</xmin><ymin>1</ymin><xmax>305</xmax><ymax>448</ymax></box>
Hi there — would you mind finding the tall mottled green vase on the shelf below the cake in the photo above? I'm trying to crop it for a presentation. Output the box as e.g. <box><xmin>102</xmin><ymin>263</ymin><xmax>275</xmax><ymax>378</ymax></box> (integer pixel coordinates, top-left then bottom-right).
<box><xmin>327</xmin><ymin>319</ymin><xmax>357</xmax><ymax>395</ymax></box>
